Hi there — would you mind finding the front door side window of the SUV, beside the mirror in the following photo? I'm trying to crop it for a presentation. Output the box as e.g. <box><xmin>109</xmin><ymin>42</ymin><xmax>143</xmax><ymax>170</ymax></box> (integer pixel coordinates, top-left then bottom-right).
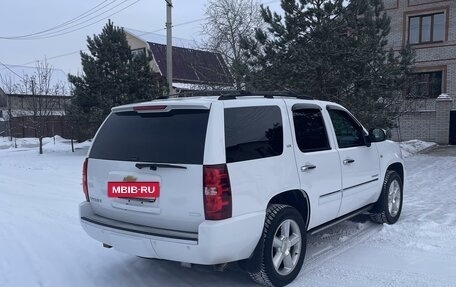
<box><xmin>328</xmin><ymin>109</ymin><xmax>366</xmax><ymax>148</ymax></box>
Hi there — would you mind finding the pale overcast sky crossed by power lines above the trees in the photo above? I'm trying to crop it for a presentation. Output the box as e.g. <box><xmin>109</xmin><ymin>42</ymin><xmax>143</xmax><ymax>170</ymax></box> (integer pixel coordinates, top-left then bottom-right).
<box><xmin>0</xmin><ymin>0</ymin><xmax>280</xmax><ymax>74</ymax></box>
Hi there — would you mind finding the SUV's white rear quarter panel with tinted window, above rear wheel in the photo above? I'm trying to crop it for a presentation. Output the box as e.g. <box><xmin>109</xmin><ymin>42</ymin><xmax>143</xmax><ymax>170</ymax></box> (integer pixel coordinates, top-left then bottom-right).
<box><xmin>223</xmin><ymin>98</ymin><xmax>299</xmax><ymax>216</ymax></box>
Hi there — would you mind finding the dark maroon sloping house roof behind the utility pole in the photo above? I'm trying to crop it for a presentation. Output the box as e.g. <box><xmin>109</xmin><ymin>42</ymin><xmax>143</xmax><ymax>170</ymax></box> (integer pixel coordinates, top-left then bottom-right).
<box><xmin>148</xmin><ymin>42</ymin><xmax>233</xmax><ymax>86</ymax></box>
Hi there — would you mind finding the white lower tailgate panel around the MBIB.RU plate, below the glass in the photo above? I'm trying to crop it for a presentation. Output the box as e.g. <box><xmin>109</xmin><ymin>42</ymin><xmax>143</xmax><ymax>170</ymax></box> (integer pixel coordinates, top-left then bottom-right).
<box><xmin>88</xmin><ymin>159</ymin><xmax>204</xmax><ymax>232</ymax></box>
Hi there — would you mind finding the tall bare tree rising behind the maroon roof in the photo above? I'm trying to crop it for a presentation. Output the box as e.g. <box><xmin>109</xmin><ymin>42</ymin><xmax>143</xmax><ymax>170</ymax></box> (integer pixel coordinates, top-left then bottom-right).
<box><xmin>202</xmin><ymin>0</ymin><xmax>263</xmax><ymax>89</ymax></box>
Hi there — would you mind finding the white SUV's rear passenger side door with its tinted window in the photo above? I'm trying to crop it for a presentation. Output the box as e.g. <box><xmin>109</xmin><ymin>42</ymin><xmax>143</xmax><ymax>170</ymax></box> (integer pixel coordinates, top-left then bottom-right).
<box><xmin>290</xmin><ymin>104</ymin><xmax>342</xmax><ymax>229</ymax></box>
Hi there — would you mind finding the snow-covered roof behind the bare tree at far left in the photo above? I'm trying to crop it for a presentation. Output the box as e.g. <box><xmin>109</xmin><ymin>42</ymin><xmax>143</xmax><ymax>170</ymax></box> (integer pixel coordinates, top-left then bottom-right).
<box><xmin>0</xmin><ymin>64</ymin><xmax>69</xmax><ymax>95</ymax></box>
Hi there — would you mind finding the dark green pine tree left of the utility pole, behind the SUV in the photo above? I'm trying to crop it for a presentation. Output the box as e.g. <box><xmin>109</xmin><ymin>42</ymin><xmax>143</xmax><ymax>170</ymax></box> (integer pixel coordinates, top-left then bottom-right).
<box><xmin>67</xmin><ymin>21</ymin><xmax>165</xmax><ymax>140</ymax></box>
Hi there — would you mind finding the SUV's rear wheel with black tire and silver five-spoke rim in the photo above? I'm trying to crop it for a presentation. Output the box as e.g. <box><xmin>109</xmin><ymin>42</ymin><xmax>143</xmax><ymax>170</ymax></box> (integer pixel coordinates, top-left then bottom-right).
<box><xmin>247</xmin><ymin>204</ymin><xmax>306</xmax><ymax>286</ymax></box>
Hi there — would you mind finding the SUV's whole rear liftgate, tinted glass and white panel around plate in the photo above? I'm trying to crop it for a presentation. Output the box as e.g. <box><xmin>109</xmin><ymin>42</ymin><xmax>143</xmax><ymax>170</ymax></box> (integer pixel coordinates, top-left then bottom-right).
<box><xmin>88</xmin><ymin>105</ymin><xmax>210</xmax><ymax>232</ymax></box>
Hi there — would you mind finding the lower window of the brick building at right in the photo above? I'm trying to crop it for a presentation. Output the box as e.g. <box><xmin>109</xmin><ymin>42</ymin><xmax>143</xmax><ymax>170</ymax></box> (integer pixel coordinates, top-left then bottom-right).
<box><xmin>407</xmin><ymin>71</ymin><xmax>443</xmax><ymax>98</ymax></box>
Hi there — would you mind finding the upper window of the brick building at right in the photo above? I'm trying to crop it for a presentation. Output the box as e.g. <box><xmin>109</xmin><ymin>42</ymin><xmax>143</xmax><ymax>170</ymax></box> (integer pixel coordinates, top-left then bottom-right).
<box><xmin>408</xmin><ymin>13</ymin><xmax>445</xmax><ymax>45</ymax></box>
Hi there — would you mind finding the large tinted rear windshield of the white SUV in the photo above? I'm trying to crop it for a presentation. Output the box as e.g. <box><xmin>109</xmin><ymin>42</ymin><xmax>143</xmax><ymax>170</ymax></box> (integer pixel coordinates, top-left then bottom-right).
<box><xmin>89</xmin><ymin>110</ymin><xmax>209</xmax><ymax>164</ymax></box>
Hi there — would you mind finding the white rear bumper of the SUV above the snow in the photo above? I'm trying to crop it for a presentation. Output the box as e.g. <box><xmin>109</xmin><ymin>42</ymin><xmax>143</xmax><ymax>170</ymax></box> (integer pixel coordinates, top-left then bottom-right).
<box><xmin>79</xmin><ymin>202</ymin><xmax>265</xmax><ymax>265</ymax></box>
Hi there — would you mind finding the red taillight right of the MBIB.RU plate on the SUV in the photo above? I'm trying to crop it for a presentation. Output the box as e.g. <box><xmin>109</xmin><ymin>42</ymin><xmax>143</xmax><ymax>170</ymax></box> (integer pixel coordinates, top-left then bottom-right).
<box><xmin>203</xmin><ymin>164</ymin><xmax>232</xmax><ymax>220</ymax></box>
